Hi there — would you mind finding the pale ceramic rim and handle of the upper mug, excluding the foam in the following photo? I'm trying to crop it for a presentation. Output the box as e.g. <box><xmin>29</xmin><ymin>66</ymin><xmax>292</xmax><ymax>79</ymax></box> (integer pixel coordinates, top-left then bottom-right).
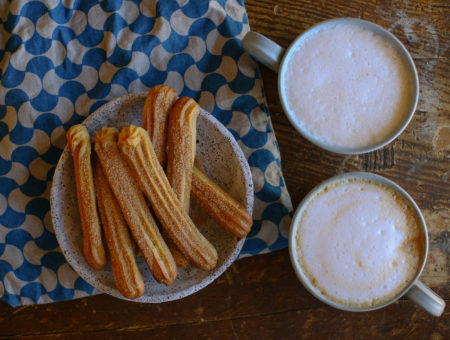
<box><xmin>242</xmin><ymin>18</ymin><xmax>419</xmax><ymax>154</ymax></box>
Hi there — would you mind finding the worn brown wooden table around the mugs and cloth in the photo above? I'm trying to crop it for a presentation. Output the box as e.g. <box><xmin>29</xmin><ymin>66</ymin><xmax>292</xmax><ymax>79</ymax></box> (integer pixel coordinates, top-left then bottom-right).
<box><xmin>0</xmin><ymin>0</ymin><xmax>450</xmax><ymax>339</ymax></box>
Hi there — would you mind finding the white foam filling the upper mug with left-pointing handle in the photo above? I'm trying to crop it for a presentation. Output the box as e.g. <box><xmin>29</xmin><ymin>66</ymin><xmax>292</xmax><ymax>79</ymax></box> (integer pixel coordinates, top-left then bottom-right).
<box><xmin>284</xmin><ymin>24</ymin><xmax>410</xmax><ymax>148</ymax></box>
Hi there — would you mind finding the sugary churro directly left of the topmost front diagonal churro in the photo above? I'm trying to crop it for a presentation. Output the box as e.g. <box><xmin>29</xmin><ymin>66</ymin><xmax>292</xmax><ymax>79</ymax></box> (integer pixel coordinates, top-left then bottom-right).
<box><xmin>94</xmin><ymin>127</ymin><xmax>177</xmax><ymax>285</ymax></box>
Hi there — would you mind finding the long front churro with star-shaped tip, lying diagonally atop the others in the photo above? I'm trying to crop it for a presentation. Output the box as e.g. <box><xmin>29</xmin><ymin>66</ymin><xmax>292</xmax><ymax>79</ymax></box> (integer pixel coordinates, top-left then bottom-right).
<box><xmin>118</xmin><ymin>125</ymin><xmax>217</xmax><ymax>270</ymax></box>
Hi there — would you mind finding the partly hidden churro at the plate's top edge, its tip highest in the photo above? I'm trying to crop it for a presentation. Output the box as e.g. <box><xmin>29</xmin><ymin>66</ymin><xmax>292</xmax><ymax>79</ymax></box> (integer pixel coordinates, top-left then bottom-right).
<box><xmin>142</xmin><ymin>85</ymin><xmax>177</xmax><ymax>167</ymax></box>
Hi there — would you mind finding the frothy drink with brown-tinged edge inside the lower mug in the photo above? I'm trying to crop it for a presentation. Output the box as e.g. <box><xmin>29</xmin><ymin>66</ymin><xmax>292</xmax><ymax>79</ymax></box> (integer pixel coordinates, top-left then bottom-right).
<box><xmin>295</xmin><ymin>178</ymin><xmax>425</xmax><ymax>308</ymax></box>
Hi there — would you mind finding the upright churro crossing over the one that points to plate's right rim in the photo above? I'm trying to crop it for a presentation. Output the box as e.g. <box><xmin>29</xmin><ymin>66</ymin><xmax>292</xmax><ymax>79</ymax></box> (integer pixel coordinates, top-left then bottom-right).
<box><xmin>167</xmin><ymin>97</ymin><xmax>200</xmax><ymax>211</ymax></box>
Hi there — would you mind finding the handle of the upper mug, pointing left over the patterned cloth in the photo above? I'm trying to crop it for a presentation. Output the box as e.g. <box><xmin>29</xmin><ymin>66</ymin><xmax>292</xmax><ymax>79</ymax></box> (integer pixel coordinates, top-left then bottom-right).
<box><xmin>242</xmin><ymin>31</ymin><xmax>285</xmax><ymax>72</ymax></box>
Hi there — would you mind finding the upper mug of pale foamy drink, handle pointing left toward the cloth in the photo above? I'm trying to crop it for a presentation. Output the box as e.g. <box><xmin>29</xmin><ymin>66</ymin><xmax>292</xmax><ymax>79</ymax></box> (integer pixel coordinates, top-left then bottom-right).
<box><xmin>242</xmin><ymin>18</ymin><xmax>419</xmax><ymax>154</ymax></box>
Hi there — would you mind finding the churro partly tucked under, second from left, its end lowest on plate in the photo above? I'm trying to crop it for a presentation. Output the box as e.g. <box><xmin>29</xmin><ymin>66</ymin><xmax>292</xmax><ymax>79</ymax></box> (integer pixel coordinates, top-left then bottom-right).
<box><xmin>92</xmin><ymin>154</ymin><xmax>145</xmax><ymax>299</ymax></box>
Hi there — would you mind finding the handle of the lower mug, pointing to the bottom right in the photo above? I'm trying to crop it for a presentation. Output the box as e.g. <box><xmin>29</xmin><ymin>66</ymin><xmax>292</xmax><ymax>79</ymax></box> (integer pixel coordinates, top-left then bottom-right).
<box><xmin>406</xmin><ymin>280</ymin><xmax>445</xmax><ymax>316</ymax></box>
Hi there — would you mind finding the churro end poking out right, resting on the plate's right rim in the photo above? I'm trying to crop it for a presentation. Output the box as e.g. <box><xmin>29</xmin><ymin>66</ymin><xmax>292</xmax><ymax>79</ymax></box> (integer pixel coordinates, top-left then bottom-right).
<box><xmin>192</xmin><ymin>167</ymin><xmax>253</xmax><ymax>238</ymax></box>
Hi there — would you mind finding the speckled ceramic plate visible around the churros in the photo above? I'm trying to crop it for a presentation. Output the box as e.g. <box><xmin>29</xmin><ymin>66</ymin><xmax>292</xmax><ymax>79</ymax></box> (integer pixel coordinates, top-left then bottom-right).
<box><xmin>51</xmin><ymin>93</ymin><xmax>253</xmax><ymax>303</ymax></box>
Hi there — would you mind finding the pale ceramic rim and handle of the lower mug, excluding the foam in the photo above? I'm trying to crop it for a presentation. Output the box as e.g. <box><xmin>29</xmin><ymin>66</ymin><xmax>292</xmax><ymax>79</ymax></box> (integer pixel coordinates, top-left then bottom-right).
<box><xmin>289</xmin><ymin>172</ymin><xmax>445</xmax><ymax>316</ymax></box>
